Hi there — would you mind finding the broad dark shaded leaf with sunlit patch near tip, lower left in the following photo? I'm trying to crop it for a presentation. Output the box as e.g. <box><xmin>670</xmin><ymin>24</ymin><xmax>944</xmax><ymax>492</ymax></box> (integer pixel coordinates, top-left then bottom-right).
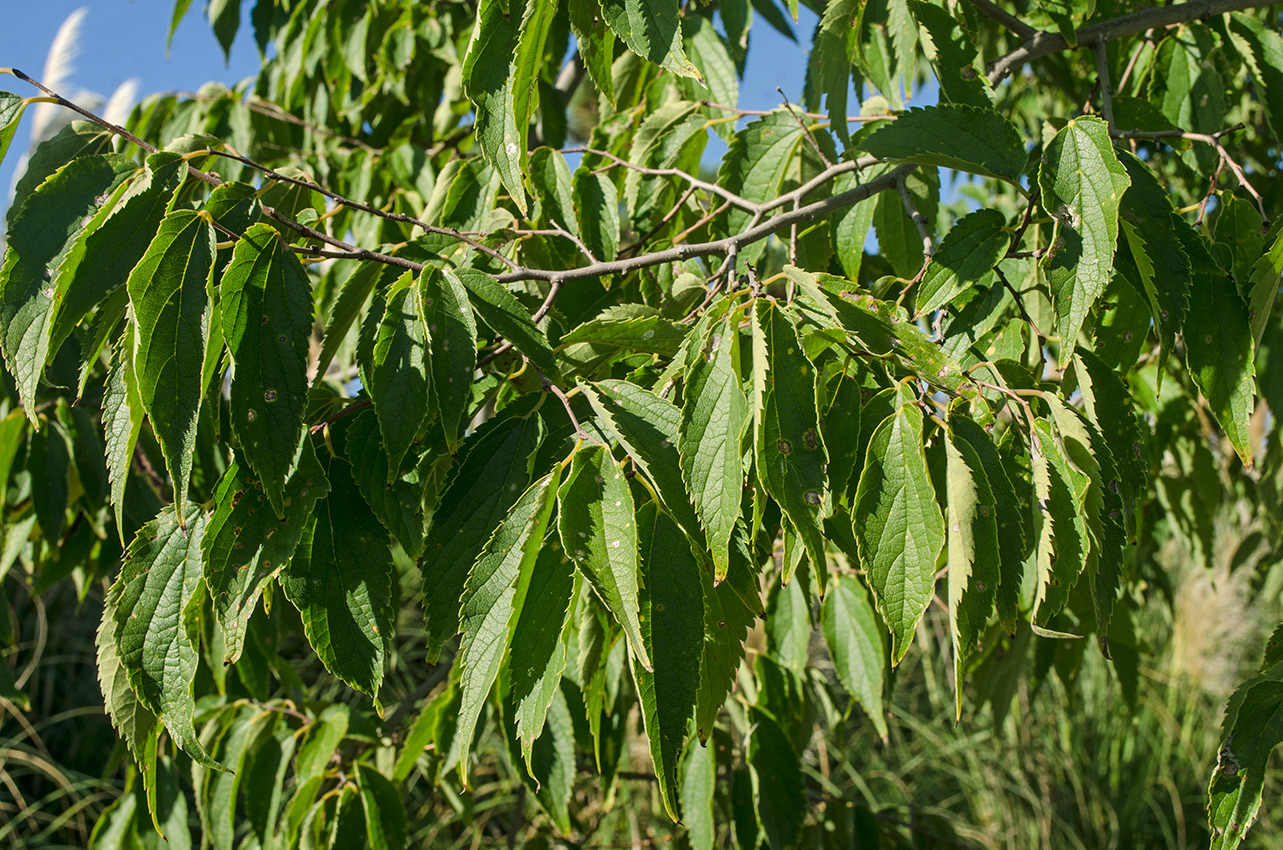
<box><xmin>280</xmin><ymin>458</ymin><xmax>393</xmax><ymax>708</ymax></box>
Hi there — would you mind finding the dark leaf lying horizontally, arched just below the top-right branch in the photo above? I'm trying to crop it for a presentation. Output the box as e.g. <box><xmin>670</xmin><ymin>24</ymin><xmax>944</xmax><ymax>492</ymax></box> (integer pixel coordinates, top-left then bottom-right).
<box><xmin>860</xmin><ymin>104</ymin><xmax>1026</xmax><ymax>184</ymax></box>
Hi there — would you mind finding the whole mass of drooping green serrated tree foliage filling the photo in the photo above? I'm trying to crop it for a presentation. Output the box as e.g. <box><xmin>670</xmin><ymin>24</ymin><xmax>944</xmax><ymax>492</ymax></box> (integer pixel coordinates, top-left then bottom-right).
<box><xmin>0</xmin><ymin>0</ymin><xmax>1283</xmax><ymax>850</ymax></box>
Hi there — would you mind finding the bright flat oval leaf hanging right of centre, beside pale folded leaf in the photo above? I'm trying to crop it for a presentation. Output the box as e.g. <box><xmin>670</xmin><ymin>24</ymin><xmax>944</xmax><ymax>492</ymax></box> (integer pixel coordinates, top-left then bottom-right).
<box><xmin>852</xmin><ymin>404</ymin><xmax>944</xmax><ymax>664</ymax></box>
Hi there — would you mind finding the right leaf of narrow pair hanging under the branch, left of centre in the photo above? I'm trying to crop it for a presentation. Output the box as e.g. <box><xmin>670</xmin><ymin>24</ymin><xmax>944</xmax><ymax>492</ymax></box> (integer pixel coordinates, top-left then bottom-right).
<box><xmin>418</xmin><ymin>268</ymin><xmax>477</xmax><ymax>451</ymax></box>
